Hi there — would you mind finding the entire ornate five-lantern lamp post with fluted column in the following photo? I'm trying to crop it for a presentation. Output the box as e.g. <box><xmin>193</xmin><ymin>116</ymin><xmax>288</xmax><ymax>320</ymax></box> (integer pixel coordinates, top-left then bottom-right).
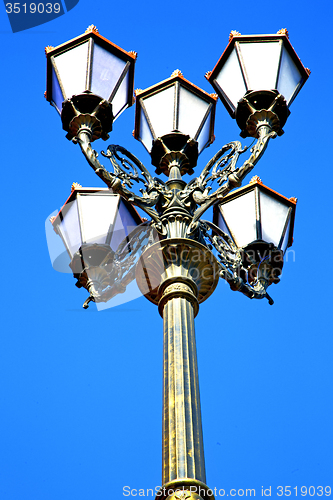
<box><xmin>46</xmin><ymin>27</ymin><xmax>309</xmax><ymax>500</ymax></box>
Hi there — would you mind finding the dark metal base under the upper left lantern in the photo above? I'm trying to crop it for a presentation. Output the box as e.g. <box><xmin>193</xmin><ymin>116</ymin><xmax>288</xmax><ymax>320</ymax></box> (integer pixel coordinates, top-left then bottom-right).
<box><xmin>61</xmin><ymin>91</ymin><xmax>113</xmax><ymax>142</ymax></box>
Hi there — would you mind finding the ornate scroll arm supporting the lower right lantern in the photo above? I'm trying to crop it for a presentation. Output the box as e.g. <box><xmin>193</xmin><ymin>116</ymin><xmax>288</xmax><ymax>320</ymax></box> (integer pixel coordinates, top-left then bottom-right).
<box><xmin>199</xmin><ymin>220</ymin><xmax>274</xmax><ymax>305</ymax></box>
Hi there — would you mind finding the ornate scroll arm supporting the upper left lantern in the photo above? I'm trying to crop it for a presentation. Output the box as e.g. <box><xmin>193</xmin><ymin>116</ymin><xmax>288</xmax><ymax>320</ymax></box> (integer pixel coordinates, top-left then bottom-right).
<box><xmin>75</xmin><ymin>130</ymin><xmax>164</xmax><ymax>230</ymax></box>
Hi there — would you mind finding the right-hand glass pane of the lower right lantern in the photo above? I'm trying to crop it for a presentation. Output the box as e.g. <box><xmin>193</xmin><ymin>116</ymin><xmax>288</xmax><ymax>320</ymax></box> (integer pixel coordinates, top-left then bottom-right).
<box><xmin>260</xmin><ymin>192</ymin><xmax>289</xmax><ymax>246</ymax></box>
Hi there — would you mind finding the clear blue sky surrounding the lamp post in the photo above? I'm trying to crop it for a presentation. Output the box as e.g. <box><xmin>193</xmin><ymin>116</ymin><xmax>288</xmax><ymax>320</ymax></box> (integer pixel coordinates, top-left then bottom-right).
<box><xmin>0</xmin><ymin>0</ymin><xmax>333</xmax><ymax>500</ymax></box>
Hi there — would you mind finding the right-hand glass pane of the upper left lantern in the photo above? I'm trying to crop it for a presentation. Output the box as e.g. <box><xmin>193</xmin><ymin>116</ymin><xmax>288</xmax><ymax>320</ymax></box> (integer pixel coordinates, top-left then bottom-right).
<box><xmin>91</xmin><ymin>43</ymin><xmax>126</xmax><ymax>101</ymax></box>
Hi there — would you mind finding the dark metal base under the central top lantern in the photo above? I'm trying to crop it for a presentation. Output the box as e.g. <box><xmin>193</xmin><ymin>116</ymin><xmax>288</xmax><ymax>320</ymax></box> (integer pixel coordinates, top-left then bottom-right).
<box><xmin>150</xmin><ymin>132</ymin><xmax>199</xmax><ymax>177</ymax></box>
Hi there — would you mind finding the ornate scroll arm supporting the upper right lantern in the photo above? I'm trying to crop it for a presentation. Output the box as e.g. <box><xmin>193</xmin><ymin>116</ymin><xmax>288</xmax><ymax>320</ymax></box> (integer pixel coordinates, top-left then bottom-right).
<box><xmin>188</xmin><ymin>125</ymin><xmax>277</xmax><ymax>234</ymax></box>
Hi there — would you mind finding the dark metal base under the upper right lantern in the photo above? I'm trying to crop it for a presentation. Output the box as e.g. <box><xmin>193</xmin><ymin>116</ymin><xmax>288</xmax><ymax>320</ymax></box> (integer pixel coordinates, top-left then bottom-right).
<box><xmin>236</xmin><ymin>90</ymin><xmax>290</xmax><ymax>138</ymax></box>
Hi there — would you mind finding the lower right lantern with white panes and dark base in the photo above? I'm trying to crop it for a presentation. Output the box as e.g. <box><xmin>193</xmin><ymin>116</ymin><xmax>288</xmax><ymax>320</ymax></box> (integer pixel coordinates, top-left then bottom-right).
<box><xmin>213</xmin><ymin>176</ymin><xmax>297</xmax><ymax>288</ymax></box>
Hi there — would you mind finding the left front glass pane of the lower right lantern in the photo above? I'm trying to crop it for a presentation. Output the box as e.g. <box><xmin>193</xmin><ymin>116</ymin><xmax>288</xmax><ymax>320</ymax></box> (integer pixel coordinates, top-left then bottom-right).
<box><xmin>221</xmin><ymin>191</ymin><xmax>257</xmax><ymax>247</ymax></box>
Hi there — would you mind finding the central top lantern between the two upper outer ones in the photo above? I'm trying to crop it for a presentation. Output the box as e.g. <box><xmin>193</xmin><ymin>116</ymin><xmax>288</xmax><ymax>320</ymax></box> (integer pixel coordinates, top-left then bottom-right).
<box><xmin>134</xmin><ymin>70</ymin><xmax>217</xmax><ymax>175</ymax></box>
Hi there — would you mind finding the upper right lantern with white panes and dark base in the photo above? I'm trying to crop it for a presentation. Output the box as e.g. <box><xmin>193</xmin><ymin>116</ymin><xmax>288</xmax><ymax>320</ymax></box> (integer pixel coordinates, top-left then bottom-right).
<box><xmin>206</xmin><ymin>29</ymin><xmax>310</xmax><ymax>137</ymax></box>
